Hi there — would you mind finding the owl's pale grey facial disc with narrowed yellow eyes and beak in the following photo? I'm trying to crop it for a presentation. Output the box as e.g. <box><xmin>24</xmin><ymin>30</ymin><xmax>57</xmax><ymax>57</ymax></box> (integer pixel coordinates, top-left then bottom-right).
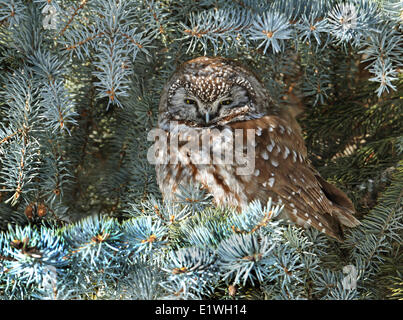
<box><xmin>168</xmin><ymin>85</ymin><xmax>253</xmax><ymax>127</ymax></box>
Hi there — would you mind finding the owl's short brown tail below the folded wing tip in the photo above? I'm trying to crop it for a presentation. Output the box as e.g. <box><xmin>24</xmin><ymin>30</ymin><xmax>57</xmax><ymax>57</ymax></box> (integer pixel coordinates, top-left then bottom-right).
<box><xmin>315</xmin><ymin>175</ymin><xmax>360</xmax><ymax>232</ymax></box>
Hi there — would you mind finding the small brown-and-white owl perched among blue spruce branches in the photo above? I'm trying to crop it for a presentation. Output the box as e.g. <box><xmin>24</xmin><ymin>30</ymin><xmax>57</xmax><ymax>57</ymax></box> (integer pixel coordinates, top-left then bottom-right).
<box><xmin>156</xmin><ymin>57</ymin><xmax>359</xmax><ymax>241</ymax></box>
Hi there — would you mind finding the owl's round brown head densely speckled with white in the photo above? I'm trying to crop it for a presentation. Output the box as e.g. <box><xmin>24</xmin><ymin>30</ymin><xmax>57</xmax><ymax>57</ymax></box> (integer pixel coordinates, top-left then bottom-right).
<box><xmin>159</xmin><ymin>57</ymin><xmax>269</xmax><ymax>127</ymax></box>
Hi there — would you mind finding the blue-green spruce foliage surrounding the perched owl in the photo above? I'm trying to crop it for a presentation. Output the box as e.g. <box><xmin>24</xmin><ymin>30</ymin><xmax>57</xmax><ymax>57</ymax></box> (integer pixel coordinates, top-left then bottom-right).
<box><xmin>0</xmin><ymin>0</ymin><xmax>403</xmax><ymax>299</ymax></box>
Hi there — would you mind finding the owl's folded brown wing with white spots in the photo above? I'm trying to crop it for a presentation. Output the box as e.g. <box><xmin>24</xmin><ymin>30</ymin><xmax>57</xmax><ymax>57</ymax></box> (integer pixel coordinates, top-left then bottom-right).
<box><xmin>231</xmin><ymin>116</ymin><xmax>359</xmax><ymax>240</ymax></box>
